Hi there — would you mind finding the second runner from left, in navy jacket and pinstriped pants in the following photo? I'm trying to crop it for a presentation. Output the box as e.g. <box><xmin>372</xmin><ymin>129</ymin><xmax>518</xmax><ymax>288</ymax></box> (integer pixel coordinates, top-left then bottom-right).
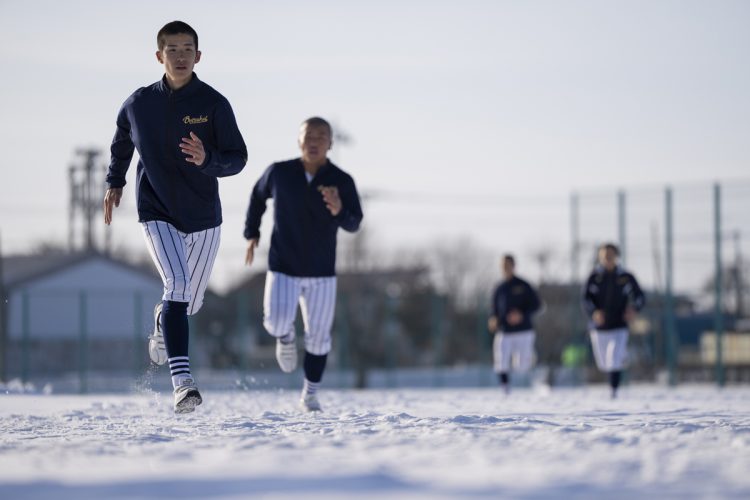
<box><xmin>244</xmin><ymin>117</ymin><xmax>362</xmax><ymax>411</ymax></box>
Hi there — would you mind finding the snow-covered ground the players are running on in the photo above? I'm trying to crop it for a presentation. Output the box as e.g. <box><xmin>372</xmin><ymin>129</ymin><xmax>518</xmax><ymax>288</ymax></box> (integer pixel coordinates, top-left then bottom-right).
<box><xmin>0</xmin><ymin>385</ymin><xmax>750</xmax><ymax>500</ymax></box>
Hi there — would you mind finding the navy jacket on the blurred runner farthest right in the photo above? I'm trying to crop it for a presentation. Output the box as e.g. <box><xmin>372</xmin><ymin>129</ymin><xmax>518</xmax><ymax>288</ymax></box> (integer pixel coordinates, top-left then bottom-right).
<box><xmin>583</xmin><ymin>266</ymin><xmax>646</xmax><ymax>330</ymax></box>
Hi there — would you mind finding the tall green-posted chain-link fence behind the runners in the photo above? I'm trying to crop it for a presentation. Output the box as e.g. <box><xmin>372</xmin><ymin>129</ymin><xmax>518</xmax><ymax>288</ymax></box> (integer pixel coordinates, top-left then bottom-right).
<box><xmin>2</xmin><ymin>181</ymin><xmax>750</xmax><ymax>391</ymax></box>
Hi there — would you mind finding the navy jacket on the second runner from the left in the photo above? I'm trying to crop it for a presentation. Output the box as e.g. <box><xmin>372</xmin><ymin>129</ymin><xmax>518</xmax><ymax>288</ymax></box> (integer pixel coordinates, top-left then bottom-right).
<box><xmin>244</xmin><ymin>158</ymin><xmax>362</xmax><ymax>277</ymax></box>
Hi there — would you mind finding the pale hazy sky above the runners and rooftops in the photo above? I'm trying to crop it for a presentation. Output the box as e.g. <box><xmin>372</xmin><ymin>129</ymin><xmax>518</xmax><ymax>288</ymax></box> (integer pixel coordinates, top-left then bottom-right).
<box><xmin>0</xmin><ymin>0</ymin><xmax>750</xmax><ymax>292</ymax></box>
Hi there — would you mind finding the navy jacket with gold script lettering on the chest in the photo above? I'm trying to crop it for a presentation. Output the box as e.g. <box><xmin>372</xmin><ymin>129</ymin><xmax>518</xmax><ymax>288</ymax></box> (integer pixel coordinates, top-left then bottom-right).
<box><xmin>107</xmin><ymin>73</ymin><xmax>247</xmax><ymax>233</ymax></box>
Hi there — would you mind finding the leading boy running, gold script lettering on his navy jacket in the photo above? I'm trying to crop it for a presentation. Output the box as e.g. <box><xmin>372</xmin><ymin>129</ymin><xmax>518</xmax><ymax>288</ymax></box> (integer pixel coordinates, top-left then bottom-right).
<box><xmin>104</xmin><ymin>21</ymin><xmax>247</xmax><ymax>413</ymax></box>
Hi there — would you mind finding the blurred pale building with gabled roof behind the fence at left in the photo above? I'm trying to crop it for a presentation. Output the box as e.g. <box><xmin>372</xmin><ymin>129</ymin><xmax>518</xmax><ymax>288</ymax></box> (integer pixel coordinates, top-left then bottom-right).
<box><xmin>0</xmin><ymin>252</ymin><xmax>162</xmax><ymax>380</ymax></box>
